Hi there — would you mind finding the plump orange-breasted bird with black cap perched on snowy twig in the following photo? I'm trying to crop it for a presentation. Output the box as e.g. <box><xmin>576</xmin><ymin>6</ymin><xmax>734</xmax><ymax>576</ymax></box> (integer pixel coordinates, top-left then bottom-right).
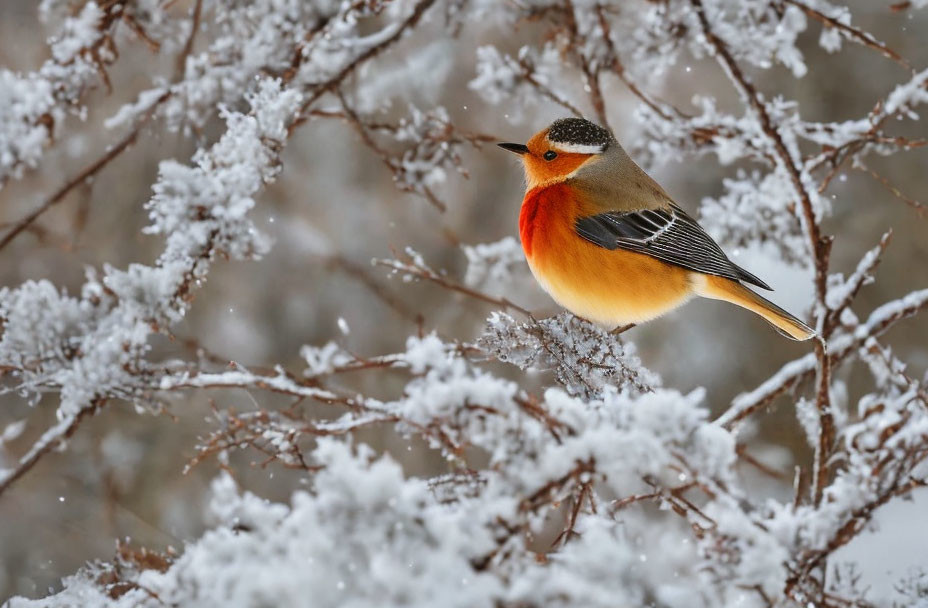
<box><xmin>498</xmin><ymin>118</ymin><xmax>816</xmax><ymax>341</ymax></box>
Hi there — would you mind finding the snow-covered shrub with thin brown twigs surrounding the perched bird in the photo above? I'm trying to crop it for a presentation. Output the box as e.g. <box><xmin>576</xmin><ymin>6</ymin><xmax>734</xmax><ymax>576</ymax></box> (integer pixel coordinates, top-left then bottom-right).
<box><xmin>0</xmin><ymin>0</ymin><xmax>928</xmax><ymax>608</ymax></box>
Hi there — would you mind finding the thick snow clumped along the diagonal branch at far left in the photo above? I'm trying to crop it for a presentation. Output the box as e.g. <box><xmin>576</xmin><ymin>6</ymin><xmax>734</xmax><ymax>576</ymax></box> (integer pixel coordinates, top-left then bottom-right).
<box><xmin>0</xmin><ymin>79</ymin><xmax>300</xmax><ymax>491</ymax></box>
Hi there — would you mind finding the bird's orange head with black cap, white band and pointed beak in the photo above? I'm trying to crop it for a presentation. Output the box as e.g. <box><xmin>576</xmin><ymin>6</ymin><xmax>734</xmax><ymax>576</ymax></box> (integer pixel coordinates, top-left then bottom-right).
<box><xmin>499</xmin><ymin>118</ymin><xmax>618</xmax><ymax>189</ymax></box>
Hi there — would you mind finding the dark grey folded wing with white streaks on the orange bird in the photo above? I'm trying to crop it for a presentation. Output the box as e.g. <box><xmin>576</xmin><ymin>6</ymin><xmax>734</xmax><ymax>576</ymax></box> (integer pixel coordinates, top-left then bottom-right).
<box><xmin>574</xmin><ymin>205</ymin><xmax>770</xmax><ymax>289</ymax></box>
